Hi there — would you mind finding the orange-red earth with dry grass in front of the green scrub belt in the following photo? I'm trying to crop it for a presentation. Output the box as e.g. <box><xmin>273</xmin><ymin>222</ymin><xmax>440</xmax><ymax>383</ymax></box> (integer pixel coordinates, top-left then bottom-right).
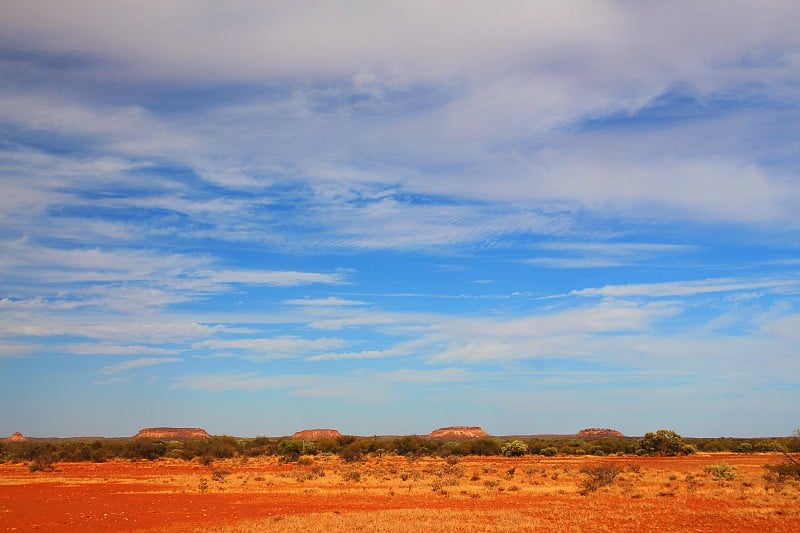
<box><xmin>0</xmin><ymin>453</ymin><xmax>800</xmax><ymax>532</ymax></box>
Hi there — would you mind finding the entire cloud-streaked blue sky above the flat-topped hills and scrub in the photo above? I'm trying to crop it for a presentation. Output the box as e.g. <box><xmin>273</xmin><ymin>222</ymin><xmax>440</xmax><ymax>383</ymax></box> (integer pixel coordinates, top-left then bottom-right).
<box><xmin>0</xmin><ymin>0</ymin><xmax>800</xmax><ymax>436</ymax></box>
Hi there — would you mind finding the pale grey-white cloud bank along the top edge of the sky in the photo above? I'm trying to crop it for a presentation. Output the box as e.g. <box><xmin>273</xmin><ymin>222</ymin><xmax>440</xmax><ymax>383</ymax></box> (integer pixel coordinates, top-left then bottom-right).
<box><xmin>3</xmin><ymin>0</ymin><xmax>797</xmax><ymax>88</ymax></box>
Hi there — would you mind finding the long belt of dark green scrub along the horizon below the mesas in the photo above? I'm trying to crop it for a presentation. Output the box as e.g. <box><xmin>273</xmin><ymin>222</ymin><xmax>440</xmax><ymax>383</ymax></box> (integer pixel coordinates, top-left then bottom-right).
<box><xmin>0</xmin><ymin>430</ymin><xmax>800</xmax><ymax>474</ymax></box>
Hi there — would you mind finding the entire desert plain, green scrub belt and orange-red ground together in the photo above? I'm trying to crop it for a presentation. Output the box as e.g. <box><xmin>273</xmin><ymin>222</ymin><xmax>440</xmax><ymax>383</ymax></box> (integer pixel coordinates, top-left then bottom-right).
<box><xmin>0</xmin><ymin>430</ymin><xmax>800</xmax><ymax>532</ymax></box>
